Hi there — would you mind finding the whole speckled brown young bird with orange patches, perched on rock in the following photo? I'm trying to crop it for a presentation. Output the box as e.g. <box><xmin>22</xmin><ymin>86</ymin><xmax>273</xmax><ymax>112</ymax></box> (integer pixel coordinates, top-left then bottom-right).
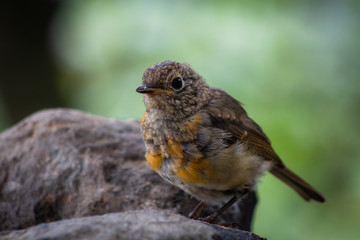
<box><xmin>136</xmin><ymin>61</ymin><xmax>325</xmax><ymax>222</ymax></box>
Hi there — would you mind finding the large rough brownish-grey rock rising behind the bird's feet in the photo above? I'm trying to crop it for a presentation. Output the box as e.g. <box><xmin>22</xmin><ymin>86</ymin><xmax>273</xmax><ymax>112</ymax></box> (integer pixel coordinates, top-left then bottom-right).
<box><xmin>0</xmin><ymin>109</ymin><xmax>262</xmax><ymax>239</ymax></box>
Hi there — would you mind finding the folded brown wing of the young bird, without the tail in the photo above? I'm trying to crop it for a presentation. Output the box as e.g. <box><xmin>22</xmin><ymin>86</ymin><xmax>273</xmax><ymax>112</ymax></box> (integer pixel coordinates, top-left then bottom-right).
<box><xmin>206</xmin><ymin>89</ymin><xmax>284</xmax><ymax>167</ymax></box>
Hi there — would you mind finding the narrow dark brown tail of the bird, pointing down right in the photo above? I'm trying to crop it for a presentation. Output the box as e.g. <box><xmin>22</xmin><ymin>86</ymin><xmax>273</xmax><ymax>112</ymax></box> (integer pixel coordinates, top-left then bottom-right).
<box><xmin>270</xmin><ymin>166</ymin><xmax>325</xmax><ymax>202</ymax></box>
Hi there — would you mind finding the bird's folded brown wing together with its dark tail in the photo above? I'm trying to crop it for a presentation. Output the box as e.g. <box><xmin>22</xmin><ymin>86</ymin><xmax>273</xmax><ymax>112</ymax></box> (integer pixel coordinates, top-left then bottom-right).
<box><xmin>207</xmin><ymin>89</ymin><xmax>325</xmax><ymax>202</ymax></box>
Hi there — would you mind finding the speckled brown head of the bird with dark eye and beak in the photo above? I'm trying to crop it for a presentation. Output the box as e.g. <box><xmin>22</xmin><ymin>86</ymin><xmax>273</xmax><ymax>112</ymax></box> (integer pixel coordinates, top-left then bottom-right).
<box><xmin>136</xmin><ymin>61</ymin><xmax>210</xmax><ymax>116</ymax></box>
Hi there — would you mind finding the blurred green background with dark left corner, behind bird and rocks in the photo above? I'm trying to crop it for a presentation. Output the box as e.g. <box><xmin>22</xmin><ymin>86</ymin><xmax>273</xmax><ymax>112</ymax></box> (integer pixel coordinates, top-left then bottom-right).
<box><xmin>0</xmin><ymin>0</ymin><xmax>360</xmax><ymax>240</ymax></box>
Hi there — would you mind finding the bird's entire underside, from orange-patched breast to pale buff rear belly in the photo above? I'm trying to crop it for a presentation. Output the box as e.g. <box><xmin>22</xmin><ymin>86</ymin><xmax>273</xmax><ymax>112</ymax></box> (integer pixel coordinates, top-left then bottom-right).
<box><xmin>142</xmin><ymin>110</ymin><xmax>267</xmax><ymax>191</ymax></box>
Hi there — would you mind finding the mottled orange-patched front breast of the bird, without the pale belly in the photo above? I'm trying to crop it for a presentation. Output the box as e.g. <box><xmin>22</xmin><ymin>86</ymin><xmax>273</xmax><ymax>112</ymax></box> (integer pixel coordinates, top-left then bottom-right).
<box><xmin>141</xmin><ymin>111</ymin><xmax>205</xmax><ymax>178</ymax></box>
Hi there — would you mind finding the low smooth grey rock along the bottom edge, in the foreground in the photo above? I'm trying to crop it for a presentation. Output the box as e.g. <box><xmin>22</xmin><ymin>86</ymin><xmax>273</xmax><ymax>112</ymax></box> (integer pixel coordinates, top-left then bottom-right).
<box><xmin>0</xmin><ymin>210</ymin><xmax>261</xmax><ymax>240</ymax></box>
